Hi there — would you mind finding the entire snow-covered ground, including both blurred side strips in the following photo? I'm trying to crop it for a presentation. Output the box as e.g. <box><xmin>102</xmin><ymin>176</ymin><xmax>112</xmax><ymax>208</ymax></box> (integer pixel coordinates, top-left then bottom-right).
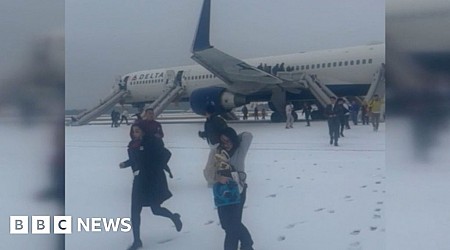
<box><xmin>0</xmin><ymin>119</ymin><xmax>450</xmax><ymax>250</ymax></box>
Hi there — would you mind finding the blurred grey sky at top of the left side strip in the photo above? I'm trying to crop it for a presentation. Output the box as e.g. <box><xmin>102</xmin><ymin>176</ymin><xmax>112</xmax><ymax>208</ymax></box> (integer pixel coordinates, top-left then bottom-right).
<box><xmin>0</xmin><ymin>0</ymin><xmax>64</xmax><ymax>79</ymax></box>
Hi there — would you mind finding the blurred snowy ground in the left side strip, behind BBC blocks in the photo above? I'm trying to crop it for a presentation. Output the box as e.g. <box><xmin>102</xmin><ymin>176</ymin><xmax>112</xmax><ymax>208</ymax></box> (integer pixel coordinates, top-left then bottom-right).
<box><xmin>0</xmin><ymin>123</ymin><xmax>64</xmax><ymax>250</ymax></box>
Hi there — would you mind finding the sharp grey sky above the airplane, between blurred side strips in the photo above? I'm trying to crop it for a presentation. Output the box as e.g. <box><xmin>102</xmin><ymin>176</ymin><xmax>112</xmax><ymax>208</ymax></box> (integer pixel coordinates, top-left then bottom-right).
<box><xmin>65</xmin><ymin>0</ymin><xmax>385</xmax><ymax>109</ymax></box>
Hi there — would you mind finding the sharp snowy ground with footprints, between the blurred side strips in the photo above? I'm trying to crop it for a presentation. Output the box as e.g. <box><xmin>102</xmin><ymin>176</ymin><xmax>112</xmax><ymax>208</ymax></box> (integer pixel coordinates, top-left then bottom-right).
<box><xmin>65</xmin><ymin>121</ymin><xmax>386</xmax><ymax>250</ymax></box>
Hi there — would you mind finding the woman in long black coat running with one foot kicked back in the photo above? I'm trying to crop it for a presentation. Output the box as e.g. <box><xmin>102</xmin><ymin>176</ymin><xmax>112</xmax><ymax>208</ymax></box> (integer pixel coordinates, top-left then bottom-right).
<box><xmin>120</xmin><ymin>124</ymin><xmax>182</xmax><ymax>250</ymax></box>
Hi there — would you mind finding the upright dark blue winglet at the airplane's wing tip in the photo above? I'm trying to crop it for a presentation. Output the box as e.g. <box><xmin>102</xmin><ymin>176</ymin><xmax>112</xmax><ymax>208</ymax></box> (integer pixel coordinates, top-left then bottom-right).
<box><xmin>192</xmin><ymin>0</ymin><xmax>212</xmax><ymax>53</ymax></box>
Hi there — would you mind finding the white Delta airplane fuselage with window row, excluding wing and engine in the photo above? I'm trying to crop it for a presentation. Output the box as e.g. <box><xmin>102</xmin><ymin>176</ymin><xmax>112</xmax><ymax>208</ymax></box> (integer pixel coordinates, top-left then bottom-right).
<box><xmin>123</xmin><ymin>44</ymin><xmax>385</xmax><ymax>104</ymax></box>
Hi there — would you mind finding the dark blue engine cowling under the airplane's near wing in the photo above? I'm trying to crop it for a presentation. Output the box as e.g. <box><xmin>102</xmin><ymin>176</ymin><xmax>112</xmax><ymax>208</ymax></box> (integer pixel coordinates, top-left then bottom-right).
<box><xmin>189</xmin><ymin>87</ymin><xmax>246</xmax><ymax>115</ymax></box>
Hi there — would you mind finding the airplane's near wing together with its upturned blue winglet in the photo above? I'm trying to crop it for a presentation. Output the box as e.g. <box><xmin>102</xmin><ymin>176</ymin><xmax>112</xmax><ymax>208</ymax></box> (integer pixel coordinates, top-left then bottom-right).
<box><xmin>191</xmin><ymin>0</ymin><xmax>283</xmax><ymax>93</ymax></box>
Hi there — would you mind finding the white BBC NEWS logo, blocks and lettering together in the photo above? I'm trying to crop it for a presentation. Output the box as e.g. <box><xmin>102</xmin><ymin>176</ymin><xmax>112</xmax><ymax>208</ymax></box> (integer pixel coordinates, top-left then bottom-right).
<box><xmin>9</xmin><ymin>216</ymin><xmax>131</xmax><ymax>234</ymax></box>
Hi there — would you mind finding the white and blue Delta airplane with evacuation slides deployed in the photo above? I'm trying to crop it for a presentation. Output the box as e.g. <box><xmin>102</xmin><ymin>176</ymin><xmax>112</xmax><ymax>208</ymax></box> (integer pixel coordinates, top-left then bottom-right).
<box><xmin>72</xmin><ymin>0</ymin><xmax>385</xmax><ymax>122</ymax></box>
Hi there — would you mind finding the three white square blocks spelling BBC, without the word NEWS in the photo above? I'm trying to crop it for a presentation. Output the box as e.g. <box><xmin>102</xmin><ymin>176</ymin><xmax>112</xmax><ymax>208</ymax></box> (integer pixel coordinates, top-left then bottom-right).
<box><xmin>9</xmin><ymin>216</ymin><xmax>72</xmax><ymax>234</ymax></box>
